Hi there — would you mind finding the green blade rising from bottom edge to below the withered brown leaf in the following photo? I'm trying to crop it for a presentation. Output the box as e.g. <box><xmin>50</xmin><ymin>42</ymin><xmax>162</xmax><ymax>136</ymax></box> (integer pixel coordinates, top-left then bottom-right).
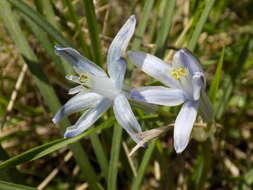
<box><xmin>132</xmin><ymin>140</ymin><xmax>156</xmax><ymax>190</ymax></box>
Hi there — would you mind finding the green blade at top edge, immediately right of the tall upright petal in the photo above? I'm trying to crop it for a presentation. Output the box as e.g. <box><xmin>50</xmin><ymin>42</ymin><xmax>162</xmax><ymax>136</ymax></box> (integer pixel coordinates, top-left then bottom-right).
<box><xmin>132</xmin><ymin>0</ymin><xmax>154</xmax><ymax>50</ymax></box>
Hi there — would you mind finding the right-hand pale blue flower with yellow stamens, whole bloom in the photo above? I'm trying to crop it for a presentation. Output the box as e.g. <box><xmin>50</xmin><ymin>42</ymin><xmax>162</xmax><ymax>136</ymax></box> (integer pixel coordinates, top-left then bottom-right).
<box><xmin>128</xmin><ymin>49</ymin><xmax>213</xmax><ymax>153</ymax></box>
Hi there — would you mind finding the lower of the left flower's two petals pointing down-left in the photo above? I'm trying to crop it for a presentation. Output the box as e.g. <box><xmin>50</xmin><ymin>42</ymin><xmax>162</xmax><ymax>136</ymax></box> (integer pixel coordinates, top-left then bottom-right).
<box><xmin>64</xmin><ymin>98</ymin><xmax>112</xmax><ymax>138</ymax></box>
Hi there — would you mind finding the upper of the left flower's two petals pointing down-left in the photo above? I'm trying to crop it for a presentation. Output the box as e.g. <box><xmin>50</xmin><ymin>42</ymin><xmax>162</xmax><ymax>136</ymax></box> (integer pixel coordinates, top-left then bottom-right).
<box><xmin>52</xmin><ymin>92</ymin><xmax>102</xmax><ymax>123</ymax></box>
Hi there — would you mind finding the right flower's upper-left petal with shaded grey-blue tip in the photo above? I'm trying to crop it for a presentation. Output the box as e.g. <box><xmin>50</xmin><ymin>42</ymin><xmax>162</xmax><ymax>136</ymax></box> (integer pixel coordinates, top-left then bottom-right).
<box><xmin>128</xmin><ymin>51</ymin><xmax>179</xmax><ymax>88</ymax></box>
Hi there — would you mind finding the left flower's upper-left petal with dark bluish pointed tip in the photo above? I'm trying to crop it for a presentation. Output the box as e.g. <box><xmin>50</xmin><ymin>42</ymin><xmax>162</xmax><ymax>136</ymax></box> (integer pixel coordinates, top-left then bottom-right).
<box><xmin>55</xmin><ymin>46</ymin><xmax>107</xmax><ymax>77</ymax></box>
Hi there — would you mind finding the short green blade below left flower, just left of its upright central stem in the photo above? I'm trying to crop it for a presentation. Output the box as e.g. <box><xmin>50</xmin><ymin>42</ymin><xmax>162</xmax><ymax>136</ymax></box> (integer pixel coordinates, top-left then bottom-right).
<box><xmin>90</xmin><ymin>133</ymin><xmax>109</xmax><ymax>179</ymax></box>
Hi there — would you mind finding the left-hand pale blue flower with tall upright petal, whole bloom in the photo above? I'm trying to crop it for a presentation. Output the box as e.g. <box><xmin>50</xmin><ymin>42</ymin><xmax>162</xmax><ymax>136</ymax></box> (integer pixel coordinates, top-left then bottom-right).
<box><xmin>53</xmin><ymin>16</ymin><xmax>141</xmax><ymax>143</ymax></box>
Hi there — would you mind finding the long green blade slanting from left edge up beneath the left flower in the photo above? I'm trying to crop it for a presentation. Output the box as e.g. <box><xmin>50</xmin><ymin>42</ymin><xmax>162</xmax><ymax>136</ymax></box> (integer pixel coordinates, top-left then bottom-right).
<box><xmin>0</xmin><ymin>118</ymin><xmax>115</xmax><ymax>170</ymax></box>
